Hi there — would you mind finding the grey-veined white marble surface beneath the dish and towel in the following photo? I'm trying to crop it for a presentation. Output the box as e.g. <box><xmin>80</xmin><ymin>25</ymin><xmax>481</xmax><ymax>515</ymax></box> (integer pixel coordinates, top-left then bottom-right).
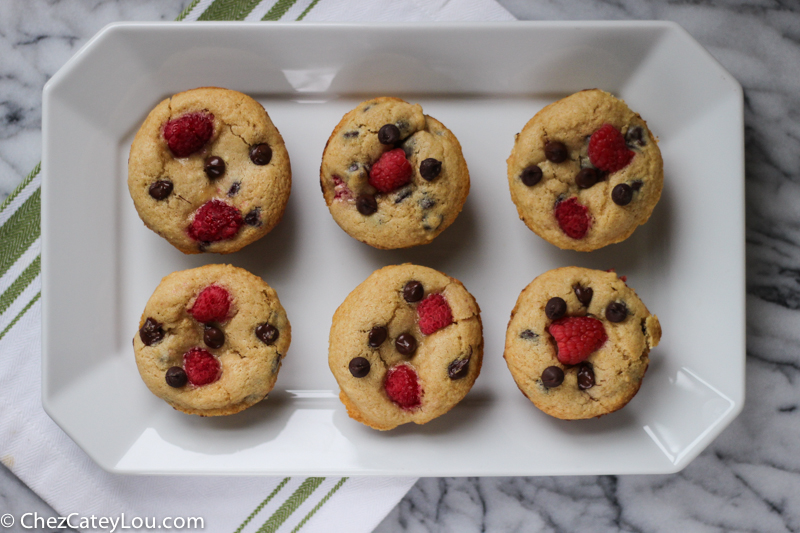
<box><xmin>0</xmin><ymin>0</ymin><xmax>800</xmax><ymax>533</ymax></box>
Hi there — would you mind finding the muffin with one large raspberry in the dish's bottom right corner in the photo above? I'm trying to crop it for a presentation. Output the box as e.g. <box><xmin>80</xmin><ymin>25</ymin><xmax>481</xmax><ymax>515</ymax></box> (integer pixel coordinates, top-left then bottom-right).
<box><xmin>503</xmin><ymin>267</ymin><xmax>661</xmax><ymax>420</ymax></box>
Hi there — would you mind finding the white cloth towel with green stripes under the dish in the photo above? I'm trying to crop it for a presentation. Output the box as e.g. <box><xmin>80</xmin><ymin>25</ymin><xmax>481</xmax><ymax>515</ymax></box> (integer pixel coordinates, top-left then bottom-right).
<box><xmin>0</xmin><ymin>0</ymin><xmax>513</xmax><ymax>533</ymax></box>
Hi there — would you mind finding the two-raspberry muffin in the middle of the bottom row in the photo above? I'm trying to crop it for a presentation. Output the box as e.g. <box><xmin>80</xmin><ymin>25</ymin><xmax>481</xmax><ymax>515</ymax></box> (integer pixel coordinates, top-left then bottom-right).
<box><xmin>328</xmin><ymin>264</ymin><xmax>483</xmax><ymax>430</ymax></box>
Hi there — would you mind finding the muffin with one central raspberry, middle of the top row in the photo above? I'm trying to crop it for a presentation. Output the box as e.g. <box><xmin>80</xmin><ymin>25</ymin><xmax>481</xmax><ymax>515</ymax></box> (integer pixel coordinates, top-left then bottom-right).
<box><xmin>320</xmin><ymin>97</ymin><xmax>469</xmax><ymax>249</ymax></box>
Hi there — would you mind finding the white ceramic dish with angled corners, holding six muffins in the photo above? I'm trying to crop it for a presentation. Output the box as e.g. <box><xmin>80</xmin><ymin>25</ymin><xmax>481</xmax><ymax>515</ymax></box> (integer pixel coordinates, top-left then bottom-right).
<box><xmin>42</xmin><ymin>22</ymin><xmax>745</xmax><ymax>476</ymax></box>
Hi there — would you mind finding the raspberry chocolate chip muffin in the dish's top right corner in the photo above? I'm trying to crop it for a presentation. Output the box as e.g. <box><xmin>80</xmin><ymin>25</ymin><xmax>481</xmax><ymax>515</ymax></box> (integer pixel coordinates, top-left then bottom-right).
<box><xmin>508</xmin><ymin>89</ymin><xmax>664</xmax><ymax>252</ymax></box>
